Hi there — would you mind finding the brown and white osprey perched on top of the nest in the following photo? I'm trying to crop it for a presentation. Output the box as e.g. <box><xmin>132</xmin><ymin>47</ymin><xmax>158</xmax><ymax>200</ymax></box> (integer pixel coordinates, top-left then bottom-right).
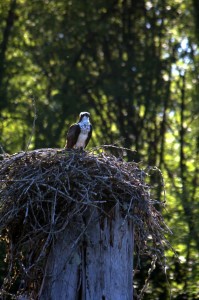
<box><xmin>65</xmin><ymin>112</ymin><xmax>92</xmax><ymax>149</ymax></box>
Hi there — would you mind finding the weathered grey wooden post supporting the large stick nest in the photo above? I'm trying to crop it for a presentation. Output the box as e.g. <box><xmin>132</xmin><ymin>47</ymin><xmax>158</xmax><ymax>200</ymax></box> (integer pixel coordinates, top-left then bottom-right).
<box><xmin>39</xmin><ymin>206</ymin><xmax>133</xmax><ymax>300</ymax></box>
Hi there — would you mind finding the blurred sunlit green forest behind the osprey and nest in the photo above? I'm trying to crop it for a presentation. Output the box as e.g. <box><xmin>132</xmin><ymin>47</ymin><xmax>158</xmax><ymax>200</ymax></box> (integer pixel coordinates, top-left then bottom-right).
<box><xmin>0</xmin><ymin>0</ymin><xmax>199</xmax><ymax>300</ymax></box>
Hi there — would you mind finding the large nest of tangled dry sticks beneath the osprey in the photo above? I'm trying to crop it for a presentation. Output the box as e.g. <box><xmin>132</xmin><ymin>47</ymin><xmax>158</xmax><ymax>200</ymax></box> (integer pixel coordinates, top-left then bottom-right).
<box><xmin>0</xmin><ymin>149</ymin><xmax>168</xmax><ymax>295</ymax></box>
